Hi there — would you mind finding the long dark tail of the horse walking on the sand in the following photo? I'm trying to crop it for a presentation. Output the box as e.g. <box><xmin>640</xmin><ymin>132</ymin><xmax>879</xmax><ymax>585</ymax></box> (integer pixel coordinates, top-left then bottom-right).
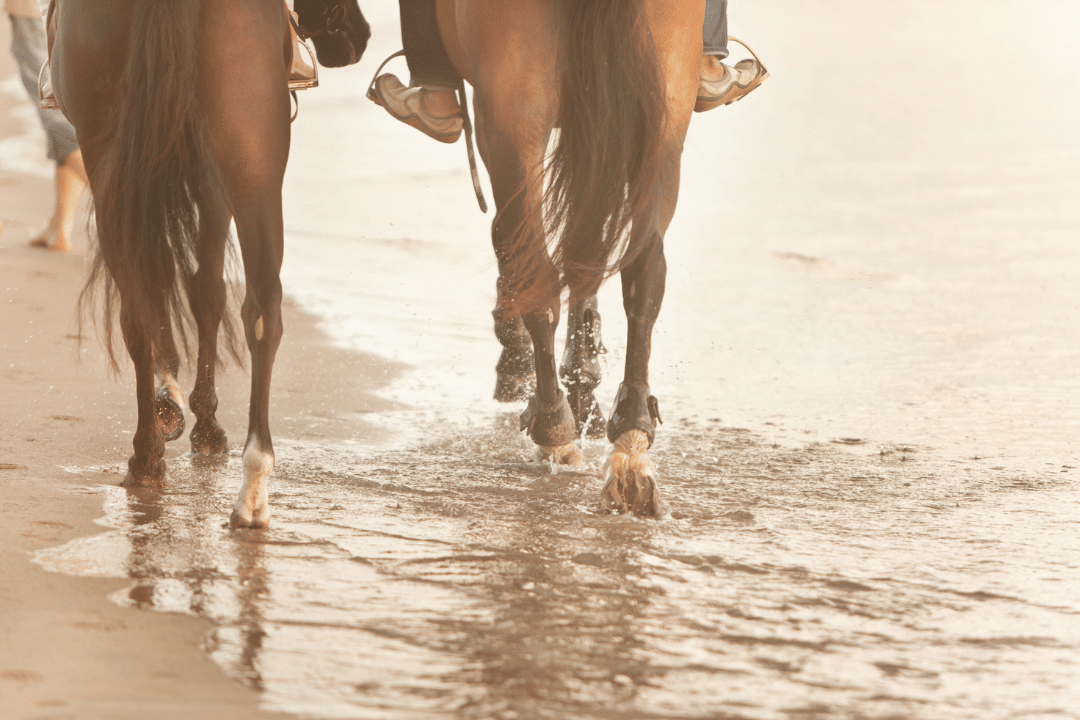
<box><xmin>80</xmin><ymin>0</ymin><xmax>231</xmax><ymax>369</ymax></box>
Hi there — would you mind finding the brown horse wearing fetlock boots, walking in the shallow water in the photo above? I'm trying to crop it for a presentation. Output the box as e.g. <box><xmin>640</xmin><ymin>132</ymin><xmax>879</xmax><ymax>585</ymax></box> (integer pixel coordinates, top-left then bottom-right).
<box><xmin>437</xmin><ymin>0</ymin><xmax>704</xmax><ymax>516</ymax></box>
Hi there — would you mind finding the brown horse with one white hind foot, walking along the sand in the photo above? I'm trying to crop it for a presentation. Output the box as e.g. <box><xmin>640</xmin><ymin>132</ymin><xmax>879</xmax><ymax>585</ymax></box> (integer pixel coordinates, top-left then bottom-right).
<box><xmin>49</xmin><ymin>0</ymin><xmax>366</xmax><ymax>528</ymax></box>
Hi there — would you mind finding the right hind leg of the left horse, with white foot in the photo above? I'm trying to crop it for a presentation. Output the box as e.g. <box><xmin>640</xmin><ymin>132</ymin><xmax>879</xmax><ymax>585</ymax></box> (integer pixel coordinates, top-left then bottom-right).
<box><xmin>199</xmin><ymin>0</ymin><xmax>292</xmax><ymax>528</ymax></box>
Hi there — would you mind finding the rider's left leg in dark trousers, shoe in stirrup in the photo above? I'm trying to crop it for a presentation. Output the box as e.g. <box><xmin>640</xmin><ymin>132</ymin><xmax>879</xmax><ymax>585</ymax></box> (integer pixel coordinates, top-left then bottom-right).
<box><xmin>368</xmin><ymin>0</ymin><xmax>461</xmax><ymax>142</ymax></box>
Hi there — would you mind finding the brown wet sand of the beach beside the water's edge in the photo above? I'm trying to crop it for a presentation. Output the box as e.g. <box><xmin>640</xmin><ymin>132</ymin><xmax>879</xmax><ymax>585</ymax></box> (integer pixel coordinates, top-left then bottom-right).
<box><xmin>0</xmin><ymin>19</ymin><xmax>382</xmax><ymax>720</ymax></box>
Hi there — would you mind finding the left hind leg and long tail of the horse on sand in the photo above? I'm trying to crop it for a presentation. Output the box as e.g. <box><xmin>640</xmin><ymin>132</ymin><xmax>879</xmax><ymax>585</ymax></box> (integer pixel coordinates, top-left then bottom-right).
<box><xmin>51</xmin><ymin>0</ymin><xmax>208</xmax><ymax>484</ymax></box>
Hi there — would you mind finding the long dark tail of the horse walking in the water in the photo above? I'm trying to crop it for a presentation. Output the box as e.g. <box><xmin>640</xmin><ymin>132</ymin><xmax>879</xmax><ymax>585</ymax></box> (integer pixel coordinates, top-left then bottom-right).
<box><xmin>531</xmin><ymin>0</ymin><xmax>666</xmax><ymax>313</ymax></box>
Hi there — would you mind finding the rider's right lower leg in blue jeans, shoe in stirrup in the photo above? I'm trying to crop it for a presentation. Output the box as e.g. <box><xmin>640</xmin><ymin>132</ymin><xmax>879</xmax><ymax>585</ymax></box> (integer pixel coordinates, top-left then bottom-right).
<box><xmin>694</xmin><ymin>0</ymin><xmax>769</xmax><ymax>112</ymax></box>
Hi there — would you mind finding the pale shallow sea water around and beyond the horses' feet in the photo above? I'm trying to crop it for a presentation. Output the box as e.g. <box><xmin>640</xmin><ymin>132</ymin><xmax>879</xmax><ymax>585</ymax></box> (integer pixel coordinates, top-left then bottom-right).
<box><xmin>29</xmin><ymin>0</ymin><xmax>1080</xmax><ymax>720</ymax></box>
